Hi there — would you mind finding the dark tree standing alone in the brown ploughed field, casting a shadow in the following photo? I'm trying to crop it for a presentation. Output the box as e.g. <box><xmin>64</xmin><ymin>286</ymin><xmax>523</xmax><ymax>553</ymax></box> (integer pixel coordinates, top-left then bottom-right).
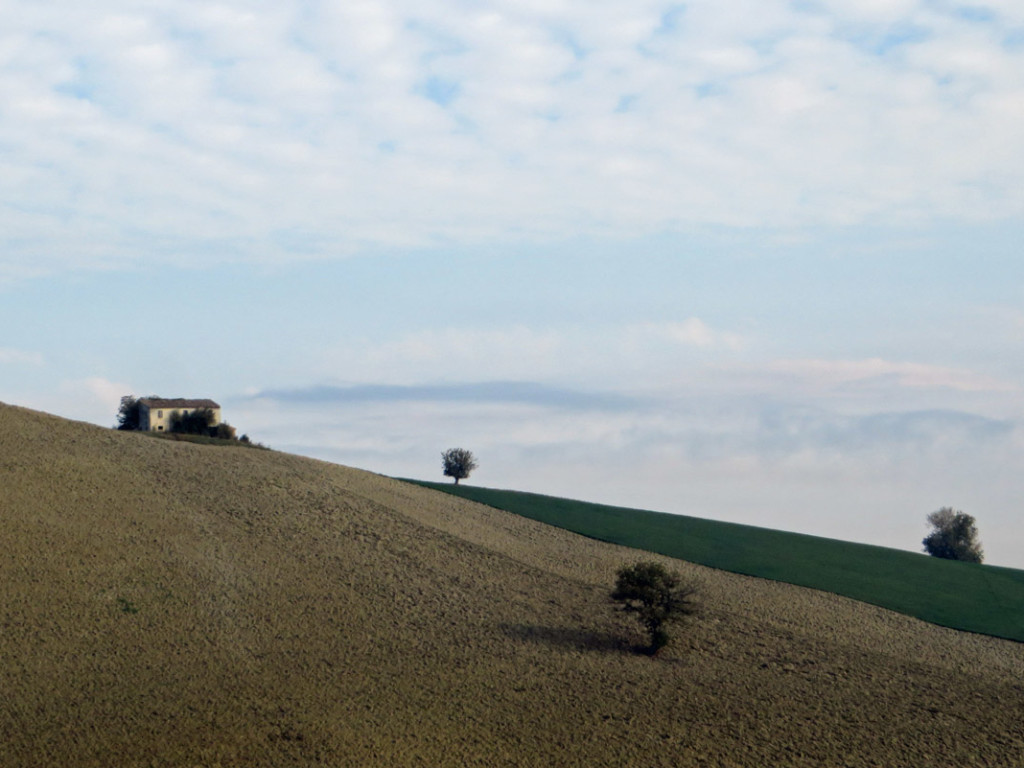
<box><xmin>611</xmin><ymin>561</ymin><xmax>697</xmax><ymax>655</ymax></box>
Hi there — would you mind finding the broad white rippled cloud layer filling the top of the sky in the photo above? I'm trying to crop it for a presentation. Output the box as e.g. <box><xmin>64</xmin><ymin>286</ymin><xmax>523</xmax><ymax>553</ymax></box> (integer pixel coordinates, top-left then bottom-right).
<box><xmin>0</xmin><ymin>0</ymin><xmax>1024</xmax><ymax>278</ymax></box>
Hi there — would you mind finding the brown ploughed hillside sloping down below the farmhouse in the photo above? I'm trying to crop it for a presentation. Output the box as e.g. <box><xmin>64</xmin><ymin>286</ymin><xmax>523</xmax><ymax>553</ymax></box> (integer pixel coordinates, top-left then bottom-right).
<box><xmin>0</xmin><ymin>406</ymin><xmax>1024</xmax><ymax>768</ymax></box>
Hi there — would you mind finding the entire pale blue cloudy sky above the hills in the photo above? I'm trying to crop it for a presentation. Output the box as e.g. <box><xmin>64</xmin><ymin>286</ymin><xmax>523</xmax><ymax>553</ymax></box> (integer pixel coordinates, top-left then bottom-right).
<box><xmin>0</xmin><ymin>0</ymin><xmax>1024</xmax><ymax>568</ymax></box>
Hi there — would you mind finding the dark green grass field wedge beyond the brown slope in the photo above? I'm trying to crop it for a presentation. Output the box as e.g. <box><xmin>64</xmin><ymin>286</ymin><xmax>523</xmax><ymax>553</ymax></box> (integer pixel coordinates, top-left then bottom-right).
<box><xmin>411</xmin><ymin>480</ymin><xmax>1024</xmax><ymax>642</ymax></box>
